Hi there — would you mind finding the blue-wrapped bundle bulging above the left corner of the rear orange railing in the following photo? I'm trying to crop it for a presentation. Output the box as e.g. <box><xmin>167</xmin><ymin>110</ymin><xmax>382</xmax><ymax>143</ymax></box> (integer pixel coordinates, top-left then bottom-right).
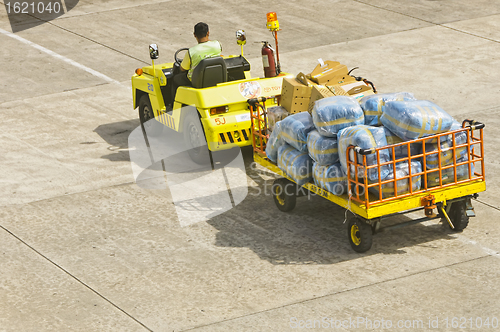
<box><xmin>338</xmin><ymin>125</ymin><xmax>391</xmax><ymax>182</ymax></box>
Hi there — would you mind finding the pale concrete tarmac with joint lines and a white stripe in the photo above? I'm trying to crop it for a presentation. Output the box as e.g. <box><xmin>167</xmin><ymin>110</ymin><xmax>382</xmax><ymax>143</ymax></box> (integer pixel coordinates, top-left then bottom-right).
<box><xmin>0</xmin><ymin>0</ymin><xmax>500</xmax><ymax>332</ymax></box>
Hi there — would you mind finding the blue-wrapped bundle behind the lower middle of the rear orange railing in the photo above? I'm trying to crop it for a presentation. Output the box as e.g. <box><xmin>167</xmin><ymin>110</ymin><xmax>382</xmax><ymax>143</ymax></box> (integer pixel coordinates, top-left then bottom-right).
<box><xmin>369</xmin><ymin>160</ymin><xmax>422</xmax><ymax>198</ymax></box>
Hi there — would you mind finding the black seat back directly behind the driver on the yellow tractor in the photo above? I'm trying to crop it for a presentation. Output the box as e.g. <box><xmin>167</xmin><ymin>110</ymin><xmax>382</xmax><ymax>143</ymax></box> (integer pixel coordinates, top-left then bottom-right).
<box><xmin>191</xmin><ymin>56</ymin><xmax>227</xmax><ymax>89</ymax></box>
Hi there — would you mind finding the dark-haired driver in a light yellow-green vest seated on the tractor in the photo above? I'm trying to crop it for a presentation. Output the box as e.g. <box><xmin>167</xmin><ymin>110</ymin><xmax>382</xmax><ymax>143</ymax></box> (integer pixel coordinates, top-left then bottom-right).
<box><xmin>174</xmin><ymin>22</ymin><xmax>222</xmax><ymax>96</ymax></box>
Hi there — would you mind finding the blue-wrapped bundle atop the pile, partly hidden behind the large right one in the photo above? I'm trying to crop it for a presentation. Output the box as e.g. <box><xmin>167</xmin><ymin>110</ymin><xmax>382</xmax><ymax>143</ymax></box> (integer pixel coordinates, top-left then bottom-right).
<box><xmin>359</xmin><ymin>92</ymin><xmax>416</xmax><ymax>126</ymax></box>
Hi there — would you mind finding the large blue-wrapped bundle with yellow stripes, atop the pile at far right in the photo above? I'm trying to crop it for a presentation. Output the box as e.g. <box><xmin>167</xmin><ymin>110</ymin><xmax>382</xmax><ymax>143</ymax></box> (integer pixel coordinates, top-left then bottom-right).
<box><xmin>380</xmin><ymin>100</ymin><xmax>453</xmax><ymax>141</ymax></box>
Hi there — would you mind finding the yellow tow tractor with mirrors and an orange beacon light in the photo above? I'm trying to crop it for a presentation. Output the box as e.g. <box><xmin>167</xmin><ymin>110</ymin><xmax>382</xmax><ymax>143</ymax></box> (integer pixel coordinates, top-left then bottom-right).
<box><xmin>132</xmin><ymin>13</ymin><xmax>285</xmax><ymax>164</ymax></box>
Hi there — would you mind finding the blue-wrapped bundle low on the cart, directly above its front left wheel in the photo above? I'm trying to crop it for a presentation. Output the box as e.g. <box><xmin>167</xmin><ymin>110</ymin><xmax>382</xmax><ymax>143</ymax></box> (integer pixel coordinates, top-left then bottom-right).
<box><xmin>278</xmin><ymin>143</ymin><xmax>313</xmax><ymax>186</ymax></box>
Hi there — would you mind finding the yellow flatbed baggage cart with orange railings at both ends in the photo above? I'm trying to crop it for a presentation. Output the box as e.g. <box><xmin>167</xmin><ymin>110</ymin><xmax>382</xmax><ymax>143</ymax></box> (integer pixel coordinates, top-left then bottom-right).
<box><xmin>248</xmin><ymin>98</ymin><xmax>486</xmax><ymax>252</ymax></box>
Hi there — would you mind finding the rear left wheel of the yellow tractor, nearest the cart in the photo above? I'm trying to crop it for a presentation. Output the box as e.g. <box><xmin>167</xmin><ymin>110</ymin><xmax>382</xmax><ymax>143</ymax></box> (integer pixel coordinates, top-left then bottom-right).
<box><xmin>183</xmin><ymin>112</ymin><xmax>210</xmax><ymax>165</ymax></box>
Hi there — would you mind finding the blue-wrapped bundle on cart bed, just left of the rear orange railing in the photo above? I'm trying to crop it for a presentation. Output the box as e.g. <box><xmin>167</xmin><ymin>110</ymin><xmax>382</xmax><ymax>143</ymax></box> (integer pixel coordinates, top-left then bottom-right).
<box><xmin>313</xmin><ymin>162</ymin><xmax>347</xmax><ymax>196</ymax></box>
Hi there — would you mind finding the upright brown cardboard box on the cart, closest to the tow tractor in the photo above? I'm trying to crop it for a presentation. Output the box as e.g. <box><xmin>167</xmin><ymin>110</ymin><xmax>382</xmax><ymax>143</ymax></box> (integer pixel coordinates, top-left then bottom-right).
<box><xmin>281</xmin><ymin>77</ymin><xmax>312</xmax><ymax>113</ymax></box>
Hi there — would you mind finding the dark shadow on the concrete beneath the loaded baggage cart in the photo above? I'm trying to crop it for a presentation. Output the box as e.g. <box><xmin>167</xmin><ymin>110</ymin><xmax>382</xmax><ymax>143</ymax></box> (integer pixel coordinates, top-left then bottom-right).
<box><xmin>202</xmin><ymin>151</ymin><xmax>458</xmax><ymax>264</ymax></box>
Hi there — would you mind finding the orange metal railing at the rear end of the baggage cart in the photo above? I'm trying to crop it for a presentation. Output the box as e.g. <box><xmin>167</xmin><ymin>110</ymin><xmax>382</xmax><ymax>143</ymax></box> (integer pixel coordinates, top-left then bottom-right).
<box><xmin>346</xmin><ymin>120</ymin><xmax>485</xmax><ymax>208</ymax></box>
